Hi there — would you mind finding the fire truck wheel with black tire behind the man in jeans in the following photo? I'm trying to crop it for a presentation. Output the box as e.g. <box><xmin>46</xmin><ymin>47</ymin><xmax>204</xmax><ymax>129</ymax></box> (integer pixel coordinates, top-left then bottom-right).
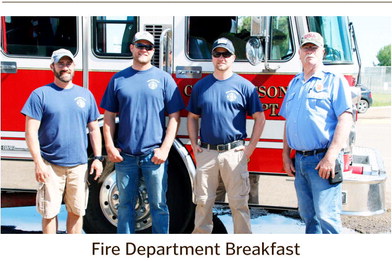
<box><xmin>83</xmin><ymin>146</ymin><xmax>195</xmax><ymax>233</ymax></box>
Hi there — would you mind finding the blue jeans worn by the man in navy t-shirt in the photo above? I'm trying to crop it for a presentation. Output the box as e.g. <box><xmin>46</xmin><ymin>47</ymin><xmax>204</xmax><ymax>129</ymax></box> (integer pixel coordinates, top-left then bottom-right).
<box><xmin>115</xmin><ymin>152</ymin><xmax>169</xmax><ymax>234</ymax></box>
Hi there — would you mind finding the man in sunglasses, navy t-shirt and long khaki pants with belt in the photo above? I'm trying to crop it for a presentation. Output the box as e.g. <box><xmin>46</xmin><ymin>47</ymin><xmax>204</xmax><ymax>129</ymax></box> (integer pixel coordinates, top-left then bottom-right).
<box><xmin>187</xmin><ymin>38</ymin><xmax>265</xmax><ymax>233</ymax></box>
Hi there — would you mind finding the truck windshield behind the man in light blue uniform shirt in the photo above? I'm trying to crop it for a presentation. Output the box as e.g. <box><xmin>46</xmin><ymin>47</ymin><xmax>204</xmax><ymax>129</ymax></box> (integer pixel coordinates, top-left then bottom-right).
<box><xmin>307</xmin><ymin>16</ymin><xmax>353</xmax><ymax>64</ymax></box>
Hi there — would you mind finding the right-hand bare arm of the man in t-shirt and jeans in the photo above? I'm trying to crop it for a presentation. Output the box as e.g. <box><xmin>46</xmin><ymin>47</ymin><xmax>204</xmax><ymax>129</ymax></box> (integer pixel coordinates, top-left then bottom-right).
<box><xmin>151</xmin><ymin>111</ymin><xmax>180</xmax><ymax>164</ymax></box>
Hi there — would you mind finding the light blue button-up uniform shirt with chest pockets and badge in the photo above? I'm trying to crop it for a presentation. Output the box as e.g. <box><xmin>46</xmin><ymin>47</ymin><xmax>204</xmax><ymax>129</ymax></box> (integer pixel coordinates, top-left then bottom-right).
<box><xmin>279</xmin><ymin>68</ymin><xmax>352</xmax><ymax>151</ymax></box>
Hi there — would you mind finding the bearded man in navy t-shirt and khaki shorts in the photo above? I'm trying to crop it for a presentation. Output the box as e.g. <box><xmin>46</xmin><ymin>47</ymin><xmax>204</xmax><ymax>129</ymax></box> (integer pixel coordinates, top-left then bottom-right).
<box><xmin>21</xmin><ymin>49</ymin><xmax>102</xmax><ymax>233</ymax></box>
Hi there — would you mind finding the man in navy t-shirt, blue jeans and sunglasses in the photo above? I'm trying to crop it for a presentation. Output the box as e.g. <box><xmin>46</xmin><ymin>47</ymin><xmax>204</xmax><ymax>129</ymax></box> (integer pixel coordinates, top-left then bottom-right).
<box><xmin>101</xmin><ymin>32</ymin><xmax>184</xmax><ymax>234</ymax></box>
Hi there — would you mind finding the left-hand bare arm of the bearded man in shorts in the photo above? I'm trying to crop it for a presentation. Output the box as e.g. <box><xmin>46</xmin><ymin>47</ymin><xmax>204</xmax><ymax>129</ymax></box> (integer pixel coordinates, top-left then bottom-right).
<box><xmin>26</xmin><ymin>116</ymin><xmax>49</xmax><ymax>182</ymax></box>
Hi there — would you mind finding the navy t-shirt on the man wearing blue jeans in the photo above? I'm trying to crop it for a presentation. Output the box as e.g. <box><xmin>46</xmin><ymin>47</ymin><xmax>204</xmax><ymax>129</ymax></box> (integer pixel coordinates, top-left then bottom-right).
<box><xmin>101</xmin><ymin>67</ymin><xmax>184</xmax><ymax>155</ymax></box>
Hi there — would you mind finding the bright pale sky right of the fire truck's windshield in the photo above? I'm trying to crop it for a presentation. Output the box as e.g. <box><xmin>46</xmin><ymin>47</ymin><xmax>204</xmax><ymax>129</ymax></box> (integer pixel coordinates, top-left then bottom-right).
<box><xmin>350</xmin><ymin>16</ymin><xmax>392</xmax><ymax>66</ymax></box>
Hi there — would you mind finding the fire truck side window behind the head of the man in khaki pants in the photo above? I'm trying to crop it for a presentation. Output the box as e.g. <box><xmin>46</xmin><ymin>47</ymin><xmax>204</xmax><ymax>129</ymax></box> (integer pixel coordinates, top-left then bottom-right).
<box><xmin>188</xmin><ymin>16</ymin><xmax>294</xmax><ymax>62</ymax></box>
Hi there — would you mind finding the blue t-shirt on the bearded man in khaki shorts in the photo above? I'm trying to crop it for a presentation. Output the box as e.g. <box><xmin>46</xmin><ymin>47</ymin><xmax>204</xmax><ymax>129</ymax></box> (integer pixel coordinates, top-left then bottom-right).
<box><xmin>21</xmin><ymin>83</ymin><xmax>100</xmax><ymax>167</ymax></box>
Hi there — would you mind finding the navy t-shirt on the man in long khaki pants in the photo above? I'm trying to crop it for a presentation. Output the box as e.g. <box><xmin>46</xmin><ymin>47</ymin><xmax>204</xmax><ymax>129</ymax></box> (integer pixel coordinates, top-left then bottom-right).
<box><xmin>187</xmin><ymin>73</ymin><xmax>263</xmax><ymax>145</ymax></box>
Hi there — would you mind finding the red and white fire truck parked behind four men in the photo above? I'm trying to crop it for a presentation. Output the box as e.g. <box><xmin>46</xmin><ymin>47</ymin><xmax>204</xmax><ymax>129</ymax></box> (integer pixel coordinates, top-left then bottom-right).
<box><xmin>0</xmin><ymin>16</ymin><xmax>386</xmax><ymax>233</ymax></box>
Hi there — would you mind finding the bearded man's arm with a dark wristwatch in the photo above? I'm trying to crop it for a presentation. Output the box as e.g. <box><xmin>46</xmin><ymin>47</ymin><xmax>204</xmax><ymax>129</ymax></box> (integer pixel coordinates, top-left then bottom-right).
<box><xmin>87</xmin><ymin>121</ymin><xmax>103</xmax><ymax>180</ymax></box>
